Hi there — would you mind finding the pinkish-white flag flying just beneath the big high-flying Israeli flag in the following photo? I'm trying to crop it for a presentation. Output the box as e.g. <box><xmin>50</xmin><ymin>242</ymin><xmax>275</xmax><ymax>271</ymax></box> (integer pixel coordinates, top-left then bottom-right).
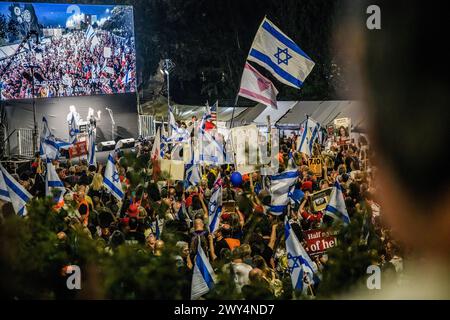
<box><xmin>239</xmin><ymin>62</ymin><xmax>278</xmax><ymax>109</ymax></box>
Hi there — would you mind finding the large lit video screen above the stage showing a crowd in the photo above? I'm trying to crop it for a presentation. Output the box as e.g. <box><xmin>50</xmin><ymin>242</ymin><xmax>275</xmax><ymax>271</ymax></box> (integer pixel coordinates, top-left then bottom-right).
<box><xmin>0</xmin><ymin>2</ymin><xmax>136</xmax><ymax>100</ymax></box>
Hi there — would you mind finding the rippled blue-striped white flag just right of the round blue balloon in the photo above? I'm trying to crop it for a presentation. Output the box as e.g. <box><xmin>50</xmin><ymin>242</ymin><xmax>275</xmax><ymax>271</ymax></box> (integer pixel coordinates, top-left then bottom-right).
<box><xmin>270</xmin><ymin>169</ymin><xmax>299</xmax><ymax>216</ymax></box>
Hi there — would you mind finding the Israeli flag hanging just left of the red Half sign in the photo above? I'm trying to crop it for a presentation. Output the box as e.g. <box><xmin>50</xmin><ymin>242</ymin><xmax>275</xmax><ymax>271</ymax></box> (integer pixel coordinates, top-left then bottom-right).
<box><xmin>284</xmin><ymin>216</ymin><xmax>319</xmax><ymax>294</ymax></box>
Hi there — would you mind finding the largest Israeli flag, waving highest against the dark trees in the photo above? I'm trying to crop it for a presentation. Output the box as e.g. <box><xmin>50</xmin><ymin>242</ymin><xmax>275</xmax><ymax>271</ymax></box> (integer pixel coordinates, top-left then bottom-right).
<box><xmin>247</xmin><ymin>18</ymin><xmax>314</xmax><ymax>89</ymax></box>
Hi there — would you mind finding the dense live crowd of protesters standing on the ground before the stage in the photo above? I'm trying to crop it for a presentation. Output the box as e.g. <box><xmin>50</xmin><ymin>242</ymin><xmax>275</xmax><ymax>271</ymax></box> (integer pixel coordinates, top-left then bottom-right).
<box><xmin>2</xmin><ymin>123</ymin><xmax>403</xmax><ymax>299</ymax></box>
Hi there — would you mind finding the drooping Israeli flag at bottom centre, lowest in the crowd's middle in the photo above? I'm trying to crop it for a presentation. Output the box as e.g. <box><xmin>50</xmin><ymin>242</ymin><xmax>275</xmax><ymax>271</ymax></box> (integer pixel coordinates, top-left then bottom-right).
<box><xmin>191</xmin><ymin>239</ymin><xmax>216</xmax><ymax>300</ymax></box>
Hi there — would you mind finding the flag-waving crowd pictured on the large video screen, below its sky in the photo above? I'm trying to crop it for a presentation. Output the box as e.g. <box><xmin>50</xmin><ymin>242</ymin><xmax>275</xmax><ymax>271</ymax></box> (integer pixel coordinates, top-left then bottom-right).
<box><xmin>0</xmin><ymin>30</ymin><xmax>136</xmax><ymax>100</ymax></box>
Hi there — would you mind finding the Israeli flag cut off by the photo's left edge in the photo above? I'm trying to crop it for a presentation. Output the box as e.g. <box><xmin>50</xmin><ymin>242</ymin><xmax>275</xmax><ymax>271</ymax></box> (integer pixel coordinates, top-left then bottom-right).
<box><xmin>0</xmin><ymin>164</ymin><xmax>32</xmax><ymax>216</ymax></box>
